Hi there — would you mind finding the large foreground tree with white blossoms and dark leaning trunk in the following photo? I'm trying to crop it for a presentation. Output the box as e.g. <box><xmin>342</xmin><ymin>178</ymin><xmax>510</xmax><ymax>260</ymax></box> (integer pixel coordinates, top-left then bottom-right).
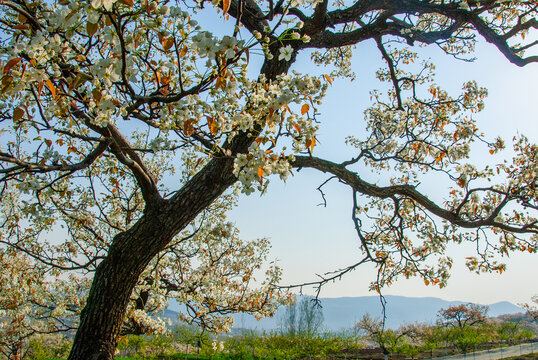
<box><xmin>0</xmin><ymin>0</ymin><xmax>538</xmax><ymax>360</ymax></box>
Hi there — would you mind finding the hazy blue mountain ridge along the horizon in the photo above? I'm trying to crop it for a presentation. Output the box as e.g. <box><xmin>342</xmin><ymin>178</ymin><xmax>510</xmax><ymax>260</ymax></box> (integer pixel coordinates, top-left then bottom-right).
<box><xmin>169</xmin><ymin>295</ymin><xmax>524</xmax><ymax>331</ymax></box>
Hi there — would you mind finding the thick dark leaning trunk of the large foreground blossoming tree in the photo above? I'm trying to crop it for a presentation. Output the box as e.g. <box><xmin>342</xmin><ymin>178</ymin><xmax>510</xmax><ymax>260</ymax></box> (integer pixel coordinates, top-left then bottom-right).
<box><xmin>68</xmin><ymin>54</ymin><xmax>286</xmax><ymax>360</ymax></box>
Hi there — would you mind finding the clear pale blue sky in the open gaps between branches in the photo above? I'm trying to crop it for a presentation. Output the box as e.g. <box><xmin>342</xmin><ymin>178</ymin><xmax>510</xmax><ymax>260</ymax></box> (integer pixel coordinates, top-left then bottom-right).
<box><xmin>226</xmin><ymin>26</ymin><xmax>538</xmax><ymax>304</ymax></box>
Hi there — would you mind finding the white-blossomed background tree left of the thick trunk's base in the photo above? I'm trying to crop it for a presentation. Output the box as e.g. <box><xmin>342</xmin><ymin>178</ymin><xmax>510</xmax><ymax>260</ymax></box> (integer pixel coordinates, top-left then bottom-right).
<box><xmin>0</xmin><ymin>249</ymin><xmax>88</xmax><ymax>359</ymax></box>
